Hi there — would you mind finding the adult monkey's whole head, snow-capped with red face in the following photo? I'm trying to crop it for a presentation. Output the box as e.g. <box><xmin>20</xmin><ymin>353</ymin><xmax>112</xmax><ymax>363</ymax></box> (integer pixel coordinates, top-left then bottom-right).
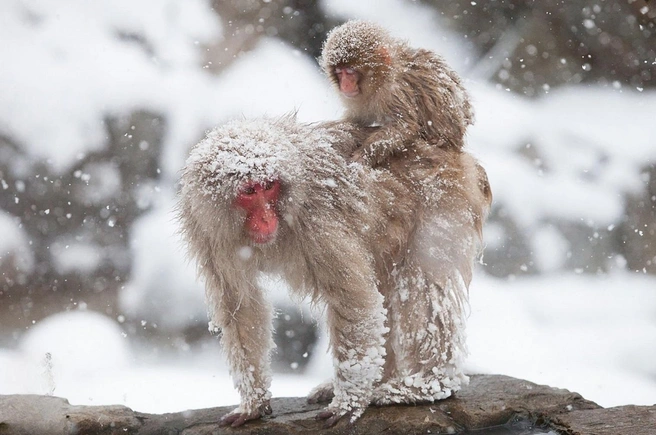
<box><xmin>181</xmin><ymin>117</ymin><xmax>304</xmax><ymax>249</ymax></box>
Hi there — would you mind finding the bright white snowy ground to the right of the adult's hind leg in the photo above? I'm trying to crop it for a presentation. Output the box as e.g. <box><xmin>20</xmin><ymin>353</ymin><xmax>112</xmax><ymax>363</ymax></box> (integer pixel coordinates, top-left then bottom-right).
<box><xmin>467</xmin><ymin>273</ymin><xmax>656</xmax><ymax>407</ymax></box>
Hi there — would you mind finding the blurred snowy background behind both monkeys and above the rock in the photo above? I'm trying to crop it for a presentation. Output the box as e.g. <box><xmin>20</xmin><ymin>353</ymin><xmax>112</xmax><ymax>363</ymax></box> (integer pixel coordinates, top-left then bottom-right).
<box><xmin>0</xmin><ymin>0</ymin><xmax>656</xmax><ymax>412</ymax></box>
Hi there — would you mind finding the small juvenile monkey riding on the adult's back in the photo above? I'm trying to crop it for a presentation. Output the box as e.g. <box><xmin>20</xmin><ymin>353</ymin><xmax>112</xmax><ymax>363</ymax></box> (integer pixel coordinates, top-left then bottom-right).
<box><xmin>320</xmin><ymin>21</ymin><xmax>473</xmax><ymax>166</ymax></box>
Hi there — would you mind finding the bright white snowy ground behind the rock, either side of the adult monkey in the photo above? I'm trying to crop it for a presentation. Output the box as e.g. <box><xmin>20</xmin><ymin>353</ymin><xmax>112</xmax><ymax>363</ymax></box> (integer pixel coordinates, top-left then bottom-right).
<box><xmin>0</xmin><ymin>273</ymin><xmax>656</xmax><ymax>413</ymax></box>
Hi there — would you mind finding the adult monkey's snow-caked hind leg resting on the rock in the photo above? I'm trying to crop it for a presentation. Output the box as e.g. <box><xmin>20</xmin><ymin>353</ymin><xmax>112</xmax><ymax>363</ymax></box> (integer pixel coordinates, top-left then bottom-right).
<box><xmin>372</xmin><ymin>265</ymin><xmax>468</xmax><ymax>405</ymax></box>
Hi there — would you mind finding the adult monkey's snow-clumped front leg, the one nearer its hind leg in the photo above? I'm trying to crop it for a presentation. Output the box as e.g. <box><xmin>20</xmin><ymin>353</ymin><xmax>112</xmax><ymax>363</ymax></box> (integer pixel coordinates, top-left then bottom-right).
<box><xmin>317</xmin><ymin>286</ymin><xmax>387</xmax><ymax>426</ymax></box>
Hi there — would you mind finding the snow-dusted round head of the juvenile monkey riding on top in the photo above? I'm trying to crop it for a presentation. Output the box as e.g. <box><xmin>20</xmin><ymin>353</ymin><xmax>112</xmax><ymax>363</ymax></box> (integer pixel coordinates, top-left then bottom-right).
<box><xmin>320</xmin><ymin>20</ymin><xmax>393</xmax><ymax>99</ymax></box>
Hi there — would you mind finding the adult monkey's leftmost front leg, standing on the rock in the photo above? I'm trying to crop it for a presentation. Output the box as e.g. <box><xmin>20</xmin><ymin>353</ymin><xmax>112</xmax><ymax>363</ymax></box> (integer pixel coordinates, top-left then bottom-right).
<box><xmin>208</xmin><ymin>285</ymin><xmax>273</xmax><ymax>427</ymax></box>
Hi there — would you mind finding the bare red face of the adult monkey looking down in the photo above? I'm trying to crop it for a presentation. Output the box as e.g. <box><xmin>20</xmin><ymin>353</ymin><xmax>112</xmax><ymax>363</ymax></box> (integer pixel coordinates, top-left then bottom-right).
<box><xmin>235</xmin><ymin>180</ymin><xmax>280</xmax><ymax>244</ymax></box>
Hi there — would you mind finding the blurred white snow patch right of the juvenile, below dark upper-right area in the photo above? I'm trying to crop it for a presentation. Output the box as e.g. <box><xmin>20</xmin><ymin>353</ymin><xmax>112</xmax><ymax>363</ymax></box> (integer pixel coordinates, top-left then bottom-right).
<box><xmin>468</xmin><ymin>83</ymin><xmax>656</xmax><ymax>229</ymax></box>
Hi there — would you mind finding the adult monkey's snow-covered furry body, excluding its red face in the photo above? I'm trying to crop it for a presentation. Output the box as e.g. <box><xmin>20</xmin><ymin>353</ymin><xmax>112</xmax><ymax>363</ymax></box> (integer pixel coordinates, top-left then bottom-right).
<box><xmin>179</xmin><ymin>118</ymin><xmax>490</xmax><ymax>419</ymax></box>
